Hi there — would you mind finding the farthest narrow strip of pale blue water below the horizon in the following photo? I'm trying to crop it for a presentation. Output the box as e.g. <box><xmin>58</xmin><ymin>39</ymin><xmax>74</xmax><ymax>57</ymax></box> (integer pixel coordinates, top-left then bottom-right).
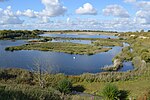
<box><xmin>40</xmin><ymin>34</ymin><xmax>118</xmax><ymax>39</ymax></box>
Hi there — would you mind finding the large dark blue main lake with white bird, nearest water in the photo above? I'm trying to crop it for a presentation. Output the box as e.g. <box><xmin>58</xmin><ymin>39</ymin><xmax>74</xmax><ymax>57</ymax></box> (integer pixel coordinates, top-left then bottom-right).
<box><xmin>0</xmin><ymin>36</ymin><xmax>133</xmax><ymax>75</ymax></box>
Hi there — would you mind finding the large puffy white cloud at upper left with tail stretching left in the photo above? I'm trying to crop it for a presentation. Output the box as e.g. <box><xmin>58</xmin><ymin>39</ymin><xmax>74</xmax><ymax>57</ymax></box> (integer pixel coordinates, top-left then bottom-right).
<box><xmin>16</xmin><ymin>0</ymin><xmax>67</xmax><ymax>18</ymax></box>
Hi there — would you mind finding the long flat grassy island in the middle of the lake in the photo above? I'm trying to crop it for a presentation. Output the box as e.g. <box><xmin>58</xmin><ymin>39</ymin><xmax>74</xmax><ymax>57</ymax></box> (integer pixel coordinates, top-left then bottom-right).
<box><xmin>5</xmin><ymin>42</ymin><xmax>111</xmax><ymax>55</ymax></box>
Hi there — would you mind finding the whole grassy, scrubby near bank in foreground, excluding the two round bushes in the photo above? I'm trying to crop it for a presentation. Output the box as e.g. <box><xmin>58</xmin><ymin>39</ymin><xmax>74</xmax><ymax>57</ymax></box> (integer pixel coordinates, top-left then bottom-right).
<box><xmin>0</xmin><ymin>67</ymin><xmax>150</xmax><ymax>100</ymax></box>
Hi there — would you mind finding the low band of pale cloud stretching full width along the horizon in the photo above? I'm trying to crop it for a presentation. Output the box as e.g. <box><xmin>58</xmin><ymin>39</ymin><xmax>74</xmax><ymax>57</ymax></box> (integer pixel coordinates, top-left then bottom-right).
<box><xmin>0</xmin><ymin>18</ymin><xmax>150</xmax><ymax>31</ymax></box>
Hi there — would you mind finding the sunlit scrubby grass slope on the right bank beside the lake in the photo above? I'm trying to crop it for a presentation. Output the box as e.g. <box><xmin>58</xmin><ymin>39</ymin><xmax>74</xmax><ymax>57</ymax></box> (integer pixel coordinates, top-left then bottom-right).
<box><xmin>115</xmin><ymin>32</ymin><xmax>150</xmax><ymax>63</ymax></box>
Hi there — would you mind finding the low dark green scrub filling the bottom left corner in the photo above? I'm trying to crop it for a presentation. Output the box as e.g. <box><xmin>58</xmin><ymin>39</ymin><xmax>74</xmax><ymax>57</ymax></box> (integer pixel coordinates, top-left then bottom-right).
<box><xmin>0</xmin><ymin>85</ymin><xmax>61</xmax><ymax>100</ymax></box>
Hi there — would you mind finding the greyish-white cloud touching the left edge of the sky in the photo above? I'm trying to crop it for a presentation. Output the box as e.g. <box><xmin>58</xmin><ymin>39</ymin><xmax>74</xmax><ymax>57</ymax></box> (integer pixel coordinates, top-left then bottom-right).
<box><xmin>0</xmin><ymin>6</ymin><xmax>24</xmax><ymax>25</ymax></box>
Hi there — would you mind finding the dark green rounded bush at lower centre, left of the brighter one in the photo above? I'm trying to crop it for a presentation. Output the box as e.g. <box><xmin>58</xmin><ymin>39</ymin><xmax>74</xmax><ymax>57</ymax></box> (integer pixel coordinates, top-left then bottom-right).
<box><xmin>57</xmin><ymin>79</ymin><xmax>72</xmax><ymax>94</ymax></box>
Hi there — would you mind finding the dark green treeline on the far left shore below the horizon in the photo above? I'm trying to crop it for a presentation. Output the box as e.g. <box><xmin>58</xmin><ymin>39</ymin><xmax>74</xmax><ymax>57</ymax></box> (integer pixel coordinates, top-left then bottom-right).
<box><xmin>0</xmin><ymin>30</ymin><xmax>43</xmax><ymax>39</ymax></box>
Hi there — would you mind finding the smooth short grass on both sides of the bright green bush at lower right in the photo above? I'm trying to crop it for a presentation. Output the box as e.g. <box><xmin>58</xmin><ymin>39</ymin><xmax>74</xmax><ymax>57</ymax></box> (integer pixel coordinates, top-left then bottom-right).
<box><xmin>75</xmin><ymin>74</ymin><xmax>150</xmax><ymax>98</ymax></box>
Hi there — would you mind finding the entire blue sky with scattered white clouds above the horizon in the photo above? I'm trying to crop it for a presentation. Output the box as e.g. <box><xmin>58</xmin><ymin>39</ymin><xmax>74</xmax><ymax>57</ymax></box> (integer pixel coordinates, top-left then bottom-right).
<box><xmin>0</xmin><ymin>0</ymin><xmax>150</xmax><ymax>31</ymax></box>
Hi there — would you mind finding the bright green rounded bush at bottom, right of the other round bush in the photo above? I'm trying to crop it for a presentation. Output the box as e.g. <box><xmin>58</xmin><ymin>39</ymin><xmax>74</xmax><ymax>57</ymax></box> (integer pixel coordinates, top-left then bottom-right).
<box><xmin>102</xmin><ymin>83</ymin><xmax>121</xmax><ymax>100</ymax></box>
